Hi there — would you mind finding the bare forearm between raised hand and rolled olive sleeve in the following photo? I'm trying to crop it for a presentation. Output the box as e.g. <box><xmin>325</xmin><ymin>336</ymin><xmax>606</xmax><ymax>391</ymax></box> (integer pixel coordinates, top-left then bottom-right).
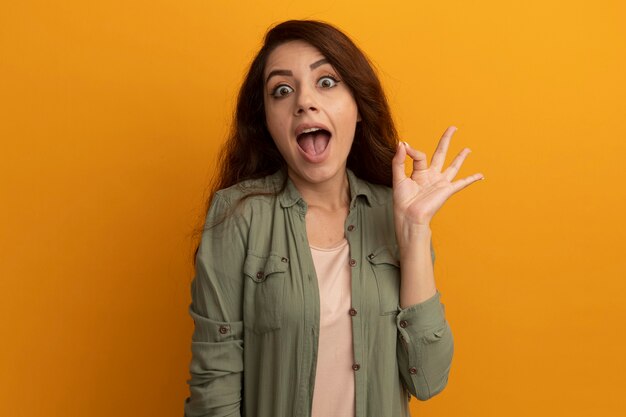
<box><xmin>398</xmin><ymin>225</ymin><xmax>437</xmax><ymax>308</ymax></box>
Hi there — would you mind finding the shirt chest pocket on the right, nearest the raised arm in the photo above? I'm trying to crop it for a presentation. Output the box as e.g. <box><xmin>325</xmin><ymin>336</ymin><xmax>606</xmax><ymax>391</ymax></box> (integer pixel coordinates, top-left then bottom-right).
<box><xmin>367</xmin><ymin>246</ymin><xmax>400</xmax><ymax>315</ymax></box>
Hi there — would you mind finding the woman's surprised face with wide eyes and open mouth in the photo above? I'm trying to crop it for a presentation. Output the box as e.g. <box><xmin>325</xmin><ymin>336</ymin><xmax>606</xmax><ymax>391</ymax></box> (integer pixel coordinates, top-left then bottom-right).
<box><xmin>264</xmin><ymin>41</ymin><xmax>360</xmax><ymax>186</ymax></box>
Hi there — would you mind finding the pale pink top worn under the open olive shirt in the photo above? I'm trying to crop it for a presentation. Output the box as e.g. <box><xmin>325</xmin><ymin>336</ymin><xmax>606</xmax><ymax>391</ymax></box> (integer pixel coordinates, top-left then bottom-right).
<box><xmin>311</xmin><ymin>239</ymin><xmax>354</xmax><ymax>417</ymax></box>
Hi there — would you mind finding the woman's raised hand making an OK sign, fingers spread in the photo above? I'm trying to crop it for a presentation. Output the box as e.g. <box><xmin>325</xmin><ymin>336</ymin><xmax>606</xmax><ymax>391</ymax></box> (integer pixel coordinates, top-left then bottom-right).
<box><xmin>392</xmin><ymin>126</ymin><xmax>483</xmax><ymax>232</ymax></box>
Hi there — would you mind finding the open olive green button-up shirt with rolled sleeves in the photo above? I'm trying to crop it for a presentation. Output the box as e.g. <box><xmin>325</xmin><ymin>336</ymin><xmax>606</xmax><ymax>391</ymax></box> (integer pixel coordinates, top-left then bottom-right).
<box><xmin>185</xmin><ymin>170</ymin><xmax>453</xmax><ymax>417</ymax></box>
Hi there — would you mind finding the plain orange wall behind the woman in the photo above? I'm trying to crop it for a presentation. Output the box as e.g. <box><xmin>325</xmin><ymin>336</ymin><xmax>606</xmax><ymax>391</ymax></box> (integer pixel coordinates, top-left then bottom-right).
<box><xmin>0</xmin><ymin>0</ymin><xmax>626</xmax><ymax>417</ymax></box>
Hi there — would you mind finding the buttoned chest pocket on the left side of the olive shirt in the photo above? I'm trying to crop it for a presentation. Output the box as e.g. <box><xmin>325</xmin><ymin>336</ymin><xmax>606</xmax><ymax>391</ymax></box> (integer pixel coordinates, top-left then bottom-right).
<box><xmin>243</xmin><ymin>253</ymin><xmax>289</xmax><ymax>333</ymax></box>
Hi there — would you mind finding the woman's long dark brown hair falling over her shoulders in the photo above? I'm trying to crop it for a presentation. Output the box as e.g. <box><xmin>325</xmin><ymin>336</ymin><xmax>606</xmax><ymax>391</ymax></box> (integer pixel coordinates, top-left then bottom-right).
<box><xmin>190</xmin><ymin>20</ymin><xmax>398</xmax><ymax>258</ymax></box>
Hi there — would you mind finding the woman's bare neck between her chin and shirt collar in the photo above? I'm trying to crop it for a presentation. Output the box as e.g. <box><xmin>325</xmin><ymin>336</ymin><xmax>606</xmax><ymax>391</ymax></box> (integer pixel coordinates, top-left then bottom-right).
<box><xmin>289</xmin><ymin>167</ymin><xmax>350</xmax><ymax>211</ymax></box>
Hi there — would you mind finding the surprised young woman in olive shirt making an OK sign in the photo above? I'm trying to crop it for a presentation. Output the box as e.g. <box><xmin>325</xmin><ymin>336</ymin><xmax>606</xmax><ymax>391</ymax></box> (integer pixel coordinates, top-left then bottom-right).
<box><xmin>185</xmin><ymin>21</ymin><xmax>482</xmax><ymax>417</ymax></box>
